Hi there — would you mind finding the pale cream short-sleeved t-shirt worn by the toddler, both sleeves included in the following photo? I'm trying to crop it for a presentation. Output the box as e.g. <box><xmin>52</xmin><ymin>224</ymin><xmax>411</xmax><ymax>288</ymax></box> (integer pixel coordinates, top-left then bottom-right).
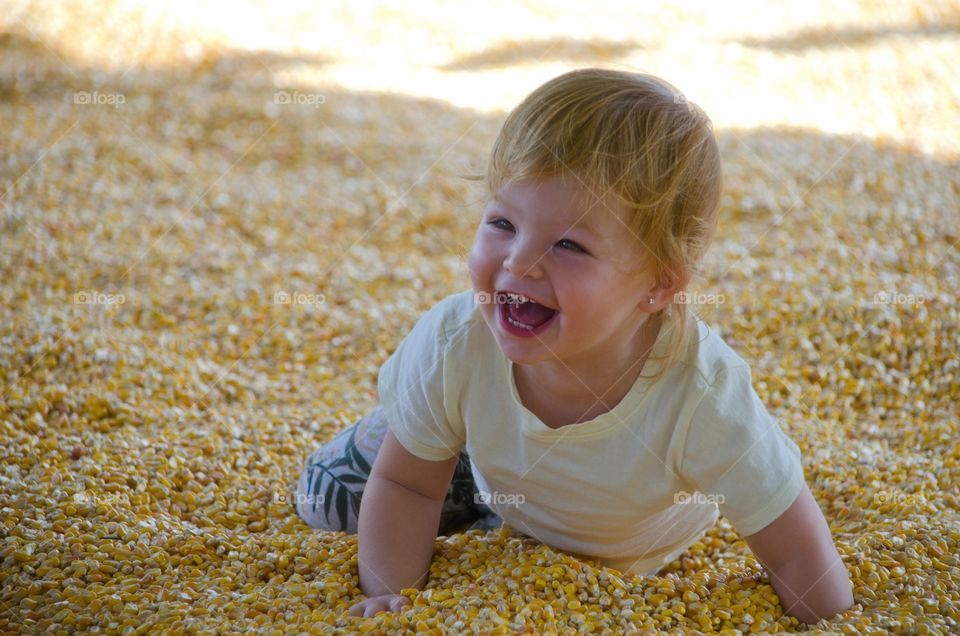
<box><xmin>378</xmin><ymin>290</ymin><xmax>804</xmax><ymax>574</ymax></box>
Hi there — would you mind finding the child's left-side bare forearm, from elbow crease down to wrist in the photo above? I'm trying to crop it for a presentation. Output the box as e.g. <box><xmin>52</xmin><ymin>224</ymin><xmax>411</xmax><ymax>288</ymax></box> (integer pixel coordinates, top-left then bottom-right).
<box><xmin>357</xmin><ymin>476</ymin><xmax>443</xmax><ymax>597</ymax></box>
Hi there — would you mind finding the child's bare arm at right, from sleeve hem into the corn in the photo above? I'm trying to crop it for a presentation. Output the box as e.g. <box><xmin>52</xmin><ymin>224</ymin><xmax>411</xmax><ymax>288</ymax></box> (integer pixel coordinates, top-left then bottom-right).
<box><xmin>744</xmin><ymin>484</ymin><xmax>853</xmax><ymax>623</ymax></box>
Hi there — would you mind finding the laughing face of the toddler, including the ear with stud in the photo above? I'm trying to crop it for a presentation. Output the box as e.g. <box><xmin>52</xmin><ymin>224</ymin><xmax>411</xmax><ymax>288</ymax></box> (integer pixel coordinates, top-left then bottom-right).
<box><xmin>468</xmin><ymin>178</ymin><xmax>669</xmax><ymax>370</ymax></box>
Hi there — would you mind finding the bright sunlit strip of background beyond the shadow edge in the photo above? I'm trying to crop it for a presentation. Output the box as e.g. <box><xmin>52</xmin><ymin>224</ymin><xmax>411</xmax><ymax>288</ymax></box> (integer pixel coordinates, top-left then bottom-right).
<box><xmin>2</xmin><ymin>0</ymin><xmax>960</xmax><ymax>147</ymax></box>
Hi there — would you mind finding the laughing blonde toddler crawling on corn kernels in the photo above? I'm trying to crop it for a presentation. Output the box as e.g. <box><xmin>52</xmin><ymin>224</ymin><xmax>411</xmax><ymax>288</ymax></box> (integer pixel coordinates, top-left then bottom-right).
<box><xmin>296</xmin><ymin>69</ymin><xmax>852</xmax><ymax>621</ymax></box>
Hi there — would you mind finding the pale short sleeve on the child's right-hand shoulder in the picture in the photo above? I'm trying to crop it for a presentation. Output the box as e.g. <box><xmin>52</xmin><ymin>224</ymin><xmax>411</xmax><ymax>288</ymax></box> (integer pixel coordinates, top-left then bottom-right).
<box><xmin>680</xmin><ymin>366</ymin><xmax>804</xmax><ymax>536</ymax></box>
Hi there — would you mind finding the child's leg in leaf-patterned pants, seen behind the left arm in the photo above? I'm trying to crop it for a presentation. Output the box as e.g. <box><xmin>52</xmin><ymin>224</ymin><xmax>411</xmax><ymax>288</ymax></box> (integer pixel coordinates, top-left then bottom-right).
<box><xmin>294</xmin><ymin>405</ymin><xmax>499</xmax><ymax>535</ymax></box>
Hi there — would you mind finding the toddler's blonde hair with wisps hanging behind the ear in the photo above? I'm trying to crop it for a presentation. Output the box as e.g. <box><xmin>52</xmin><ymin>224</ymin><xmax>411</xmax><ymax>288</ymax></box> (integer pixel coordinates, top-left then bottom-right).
<box><xmin>468</xmin><ymin>68</ymin><xmax>723</xmax><ymax>382</ymax></box>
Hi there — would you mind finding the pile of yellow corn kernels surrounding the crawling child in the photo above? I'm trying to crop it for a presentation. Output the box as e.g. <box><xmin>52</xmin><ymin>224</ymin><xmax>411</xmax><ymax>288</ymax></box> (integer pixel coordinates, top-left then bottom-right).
<box><xmin>0</xmin><ymin>1</ymin><xmax>960</xmax><ymax>634</ymax></box>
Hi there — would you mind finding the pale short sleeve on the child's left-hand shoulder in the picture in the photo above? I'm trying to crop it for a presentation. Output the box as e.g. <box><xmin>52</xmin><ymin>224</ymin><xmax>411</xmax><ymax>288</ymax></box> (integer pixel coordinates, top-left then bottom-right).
<box><xmin>377</xmin><ymin>303</ymin><xmax>466</xmax><ymax>461</ymax></box>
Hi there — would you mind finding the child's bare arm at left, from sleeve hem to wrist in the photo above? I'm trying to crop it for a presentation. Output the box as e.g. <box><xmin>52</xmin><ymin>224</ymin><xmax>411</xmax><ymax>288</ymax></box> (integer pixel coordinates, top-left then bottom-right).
<box><xmin>357</xmin><ymin>429</ymin><xmax>458</xmax><ymax>612</ymax></box>
